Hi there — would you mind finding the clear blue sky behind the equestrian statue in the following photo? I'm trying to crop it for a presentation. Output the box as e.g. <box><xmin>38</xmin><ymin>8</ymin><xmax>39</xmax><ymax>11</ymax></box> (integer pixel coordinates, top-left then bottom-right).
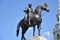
<box><xmin>0</xmin><ymin>0</ymin><xmax>58</xmax><ymax>40</ymax></box>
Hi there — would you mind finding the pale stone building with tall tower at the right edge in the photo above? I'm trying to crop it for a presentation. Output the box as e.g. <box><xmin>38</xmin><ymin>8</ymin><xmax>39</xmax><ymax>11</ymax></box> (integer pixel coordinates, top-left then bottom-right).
<box><xmin>53</xmin><ymin>0</ymin><xmax>60</xmax><ymax>40</ymax></box>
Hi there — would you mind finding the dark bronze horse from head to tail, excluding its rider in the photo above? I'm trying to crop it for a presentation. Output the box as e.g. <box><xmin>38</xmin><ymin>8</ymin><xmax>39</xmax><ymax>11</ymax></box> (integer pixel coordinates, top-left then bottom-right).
<box><xmin>16</xmin><ymin>3</ymin><xmax>49</xmax><ymax>40</ymax></box>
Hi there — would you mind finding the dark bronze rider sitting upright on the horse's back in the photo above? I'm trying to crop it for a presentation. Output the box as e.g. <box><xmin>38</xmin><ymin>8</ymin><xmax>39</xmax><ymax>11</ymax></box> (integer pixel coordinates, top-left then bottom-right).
<box><xmin>24</xmin><ymin>4</ymin><xmax>33</xmax><ymax>24</ymax></box>
